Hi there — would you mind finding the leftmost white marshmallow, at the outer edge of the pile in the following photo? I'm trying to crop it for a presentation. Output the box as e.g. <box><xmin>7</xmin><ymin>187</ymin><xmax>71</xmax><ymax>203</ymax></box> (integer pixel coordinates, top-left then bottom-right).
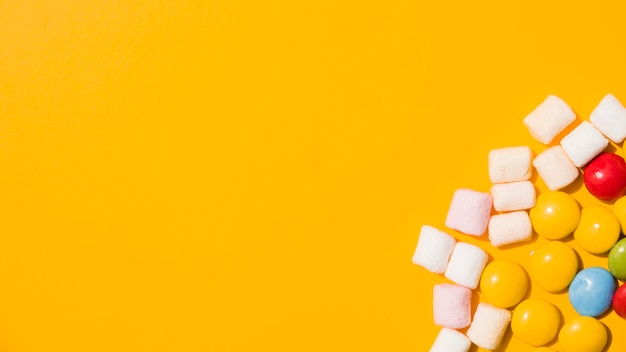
<box><xmin>413</xmin><ymin>225</ymin><xmax>456</xmax><ymax>274</ymax></box>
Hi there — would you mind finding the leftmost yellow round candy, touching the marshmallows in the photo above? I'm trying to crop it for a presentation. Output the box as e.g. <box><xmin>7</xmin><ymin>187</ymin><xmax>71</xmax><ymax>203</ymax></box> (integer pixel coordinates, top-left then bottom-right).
<box><xmin>480</xmin><ymin>259</ymin><xmax>528</xmax><ymax>308</ymax></box>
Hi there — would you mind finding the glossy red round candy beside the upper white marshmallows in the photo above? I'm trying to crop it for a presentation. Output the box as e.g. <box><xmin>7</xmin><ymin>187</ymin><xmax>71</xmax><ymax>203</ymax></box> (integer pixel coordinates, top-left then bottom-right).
<box><xmin>583</xmin><ymin>153</ymin><xmax>626</xmax><ymax>201</ymax></box>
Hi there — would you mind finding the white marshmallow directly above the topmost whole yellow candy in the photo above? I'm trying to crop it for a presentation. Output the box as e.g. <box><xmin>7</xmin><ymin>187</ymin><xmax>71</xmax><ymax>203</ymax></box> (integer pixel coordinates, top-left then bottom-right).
<box><xmin>533</xmin><ymin>145</ymin><xmax>580</xmax><ymax>191</ymax></box>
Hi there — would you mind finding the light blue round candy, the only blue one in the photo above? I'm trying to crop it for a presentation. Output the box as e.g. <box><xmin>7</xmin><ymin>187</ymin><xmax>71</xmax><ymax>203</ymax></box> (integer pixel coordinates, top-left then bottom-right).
<box><xmin>568</xmin><ymin>267</ymin><xmax>615</xmax><ymax>317</ymax></box>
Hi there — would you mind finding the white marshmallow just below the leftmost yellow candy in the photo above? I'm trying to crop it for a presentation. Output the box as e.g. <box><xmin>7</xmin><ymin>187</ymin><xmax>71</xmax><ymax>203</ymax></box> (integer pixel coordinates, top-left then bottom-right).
<box><xmin>467</xmin><ymin>302</ymin><xmax>511</xmax><ymax>351</ymax></box>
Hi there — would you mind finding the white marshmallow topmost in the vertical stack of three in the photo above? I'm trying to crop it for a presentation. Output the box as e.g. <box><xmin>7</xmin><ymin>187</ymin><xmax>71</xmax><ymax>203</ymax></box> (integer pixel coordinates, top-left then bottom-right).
<box><xmin>489</xmin><ymin>146</ymin><xmax>533</xmax><ymax>183</ymax></box>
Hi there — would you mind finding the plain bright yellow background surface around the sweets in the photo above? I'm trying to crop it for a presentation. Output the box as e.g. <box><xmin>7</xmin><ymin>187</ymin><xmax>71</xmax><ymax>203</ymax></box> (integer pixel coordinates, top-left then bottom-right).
<box><xmin>0</xmin><ymin>0</ymin><xmax>626</xmax><ymax>352</ymax></box>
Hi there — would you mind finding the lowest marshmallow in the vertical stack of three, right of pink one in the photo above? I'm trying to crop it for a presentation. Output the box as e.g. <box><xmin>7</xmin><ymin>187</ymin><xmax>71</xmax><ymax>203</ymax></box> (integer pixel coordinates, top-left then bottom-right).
<box><xmin>489</xmin><ymin>210</ymin><xmax>533</xmax><ymax>247</ymax></box>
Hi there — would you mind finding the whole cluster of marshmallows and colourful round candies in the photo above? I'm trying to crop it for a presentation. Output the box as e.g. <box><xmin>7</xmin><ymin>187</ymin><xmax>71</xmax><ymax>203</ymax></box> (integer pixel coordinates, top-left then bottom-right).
<box><xmin>413</xmin><ymin>94</ymin><xmax>626</xmax><ymax>352</ymax></box>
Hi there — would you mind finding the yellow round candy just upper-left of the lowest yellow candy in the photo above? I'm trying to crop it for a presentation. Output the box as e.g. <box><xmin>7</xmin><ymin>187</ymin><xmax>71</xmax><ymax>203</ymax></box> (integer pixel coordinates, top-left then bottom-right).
<box><xmin>511</xmin><ymin>298</ymin><xmax>561</xmax><ymax>346</ymax></box>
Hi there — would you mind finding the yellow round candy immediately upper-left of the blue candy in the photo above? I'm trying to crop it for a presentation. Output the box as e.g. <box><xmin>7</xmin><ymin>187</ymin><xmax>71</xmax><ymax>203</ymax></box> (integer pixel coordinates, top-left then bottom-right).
<box><xmin>530</xmin><ymin>241</ymin><xmax>578</xmax><ymax>293</ymax></box>
